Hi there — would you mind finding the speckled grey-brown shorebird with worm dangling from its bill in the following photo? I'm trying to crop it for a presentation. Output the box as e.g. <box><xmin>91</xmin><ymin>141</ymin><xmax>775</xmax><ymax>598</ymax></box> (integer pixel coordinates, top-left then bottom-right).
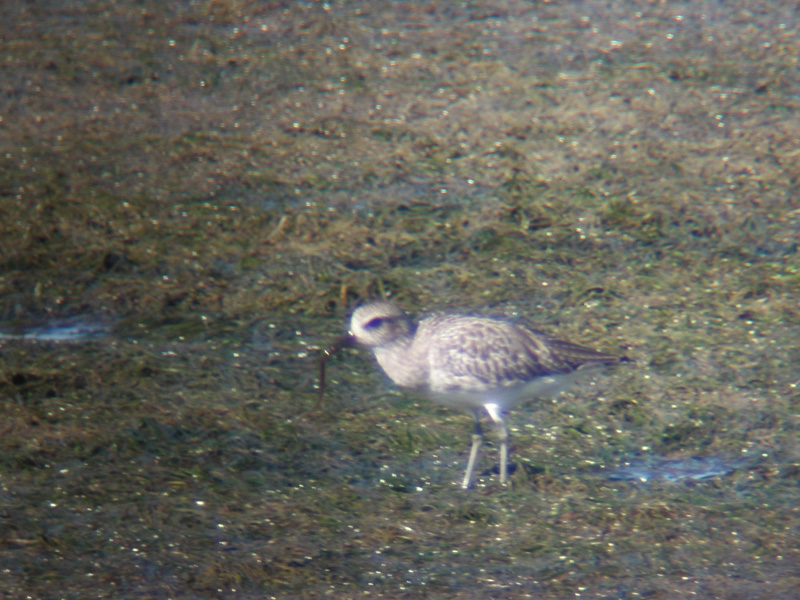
<box><xmin>320</xmin><ymin>300</ymin><xmax>629</xmax><ymax>489</ymax></box>
